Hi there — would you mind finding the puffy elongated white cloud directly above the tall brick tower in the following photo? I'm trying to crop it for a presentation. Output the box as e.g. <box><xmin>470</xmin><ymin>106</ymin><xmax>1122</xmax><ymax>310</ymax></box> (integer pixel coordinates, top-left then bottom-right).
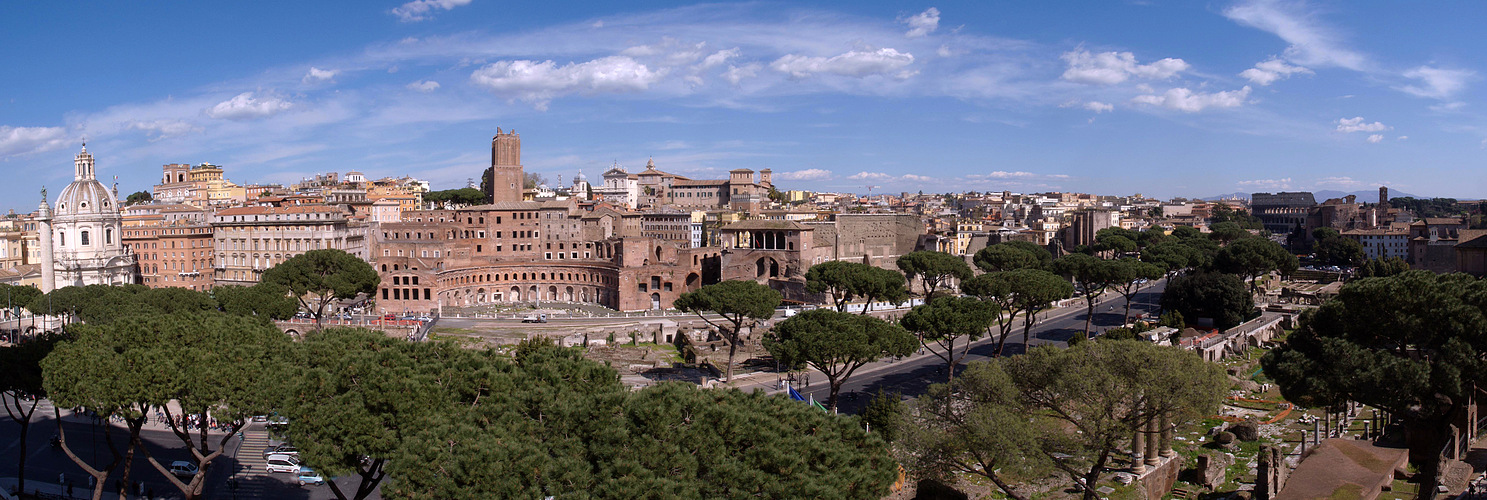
<box><xmin>470</xmin><ymin>55</ymin><xmax>666</xmax><ymax>110</ymax></box>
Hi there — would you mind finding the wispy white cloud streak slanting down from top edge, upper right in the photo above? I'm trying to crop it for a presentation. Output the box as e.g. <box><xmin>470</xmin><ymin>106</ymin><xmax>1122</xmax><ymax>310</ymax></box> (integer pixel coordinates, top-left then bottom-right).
<box><xmin>1224</xmin><ymin>0</ymin><xmax>1368</xmax><ymax>71</ymax></box>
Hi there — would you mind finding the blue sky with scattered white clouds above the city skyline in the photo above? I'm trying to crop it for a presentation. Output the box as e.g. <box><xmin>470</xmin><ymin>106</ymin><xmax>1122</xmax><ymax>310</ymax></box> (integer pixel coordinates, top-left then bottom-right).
<box><xmin>0</xmin><ymin>0</ymin><xmax>1487</xmax><ymax>206</ymax></box>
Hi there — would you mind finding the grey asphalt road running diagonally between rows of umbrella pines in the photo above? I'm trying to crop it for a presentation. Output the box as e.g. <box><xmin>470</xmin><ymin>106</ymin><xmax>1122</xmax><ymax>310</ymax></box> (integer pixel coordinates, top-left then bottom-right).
<box><xmin>761</xmin><ymin>280</ymin><xmax>1167</xmax><ymax>414</ymax></box>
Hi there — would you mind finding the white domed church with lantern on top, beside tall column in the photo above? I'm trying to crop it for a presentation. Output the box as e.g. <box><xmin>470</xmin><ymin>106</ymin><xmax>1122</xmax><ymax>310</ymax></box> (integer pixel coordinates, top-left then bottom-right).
<box><xmin>42</xmin><ymin>144</ymin><xmax>135</xmax><ymax>292</ymax></box>
